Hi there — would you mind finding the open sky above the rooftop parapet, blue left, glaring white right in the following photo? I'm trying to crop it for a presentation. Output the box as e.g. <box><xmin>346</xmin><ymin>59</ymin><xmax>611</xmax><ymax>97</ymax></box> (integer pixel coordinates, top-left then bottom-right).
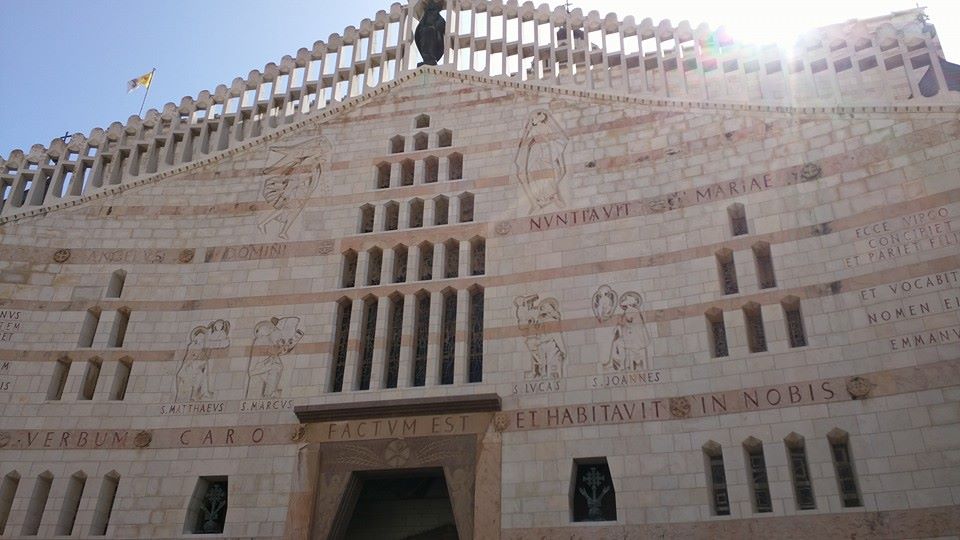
<box><xmin>0</xmin><ymin>0</ymin><xmax>960</xmax><ymax>157</ymax></box>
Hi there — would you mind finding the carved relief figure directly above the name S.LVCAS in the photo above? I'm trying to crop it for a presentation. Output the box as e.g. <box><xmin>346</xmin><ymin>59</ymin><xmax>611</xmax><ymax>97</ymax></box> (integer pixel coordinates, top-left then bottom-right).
<box><xmin>513</xmin><ymin>294</ymin><xmax>567</xmax><ymax>379</ymax></box>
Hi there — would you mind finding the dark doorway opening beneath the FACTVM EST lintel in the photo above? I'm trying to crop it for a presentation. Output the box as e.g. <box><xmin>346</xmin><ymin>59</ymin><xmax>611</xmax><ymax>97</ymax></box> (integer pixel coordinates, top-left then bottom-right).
<box><xmin>342</xmin><ymin>468</ymin><xmax>459</xmax><ymax>540</ymax></box>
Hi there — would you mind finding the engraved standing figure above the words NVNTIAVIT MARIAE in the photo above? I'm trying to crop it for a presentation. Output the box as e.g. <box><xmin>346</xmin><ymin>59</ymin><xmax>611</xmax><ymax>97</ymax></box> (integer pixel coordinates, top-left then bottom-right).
<box><xmin>513</xmin><ymin>109</ymin><xmax>570</xmax><ymax>214</ymax></box>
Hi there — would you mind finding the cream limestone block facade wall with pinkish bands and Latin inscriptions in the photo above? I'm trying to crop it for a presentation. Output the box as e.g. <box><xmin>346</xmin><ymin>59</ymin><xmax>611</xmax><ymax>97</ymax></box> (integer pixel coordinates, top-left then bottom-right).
<box><xmin>0</xmin><ymin>70</ymin><xmax>960</xmax><ymax>538</ymax></box>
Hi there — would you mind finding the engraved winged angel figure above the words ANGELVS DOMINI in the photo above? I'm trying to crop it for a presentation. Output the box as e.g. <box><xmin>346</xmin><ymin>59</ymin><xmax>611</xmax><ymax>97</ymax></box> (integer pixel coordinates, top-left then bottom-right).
<box><xmin>258</xmin><ymin>131</ymin><xmax>331</xmax><ymax>240</ymax></box>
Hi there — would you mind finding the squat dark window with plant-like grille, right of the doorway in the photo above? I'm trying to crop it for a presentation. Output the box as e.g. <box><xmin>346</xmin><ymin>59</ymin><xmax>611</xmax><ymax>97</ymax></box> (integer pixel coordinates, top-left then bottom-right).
<box><xmin>570</xmin><ymin>457</ymin><xmax>617</xmax><ymax>522</ymax></box>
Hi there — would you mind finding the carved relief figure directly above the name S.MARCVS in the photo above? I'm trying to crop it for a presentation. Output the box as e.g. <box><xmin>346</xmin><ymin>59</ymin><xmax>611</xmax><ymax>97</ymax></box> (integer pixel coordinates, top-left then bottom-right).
<box><xmin>246</xmin><ymin>317</ymin><xmax>303</xmax><ymax>399</ymax></box>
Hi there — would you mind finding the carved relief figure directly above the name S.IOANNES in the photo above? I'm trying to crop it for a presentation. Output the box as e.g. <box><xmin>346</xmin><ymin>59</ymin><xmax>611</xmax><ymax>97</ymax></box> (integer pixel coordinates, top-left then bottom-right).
<box><xmin>592</xmin><ymin>285</ymin><xmax>650</xmax><ymax>371</ymax></box>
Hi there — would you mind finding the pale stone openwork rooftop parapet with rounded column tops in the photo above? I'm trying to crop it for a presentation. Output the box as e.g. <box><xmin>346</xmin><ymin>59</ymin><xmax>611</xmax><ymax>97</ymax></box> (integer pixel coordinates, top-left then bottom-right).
<box><xmin>0</xmin><ymin>0</ymin><xmax>960</xmax><ymax>224</ymax></box>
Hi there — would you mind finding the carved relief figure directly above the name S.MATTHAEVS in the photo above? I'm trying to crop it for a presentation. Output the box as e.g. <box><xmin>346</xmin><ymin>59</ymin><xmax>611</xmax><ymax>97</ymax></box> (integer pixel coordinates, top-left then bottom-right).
<box><xmin>176</xmin><ymin>319</ymin><xmax>230</xmax><ymax>401</ymax></box>
